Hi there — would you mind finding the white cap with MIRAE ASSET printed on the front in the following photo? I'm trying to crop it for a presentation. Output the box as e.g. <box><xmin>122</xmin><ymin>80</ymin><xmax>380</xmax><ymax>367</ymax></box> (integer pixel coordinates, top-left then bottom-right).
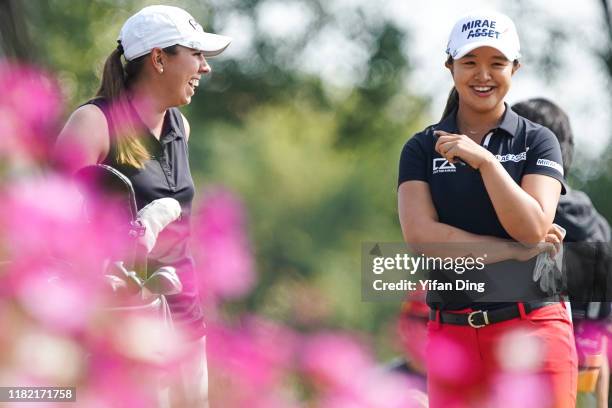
<box><xmin>446</xmin><ymin>11</ymin><xmax>521</xmax><ymax>61</ymax></box>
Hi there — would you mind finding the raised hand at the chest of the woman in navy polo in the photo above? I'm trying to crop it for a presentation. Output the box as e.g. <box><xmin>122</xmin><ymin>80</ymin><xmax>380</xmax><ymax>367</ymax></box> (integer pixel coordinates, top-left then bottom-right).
<box><xmin>434</xmin><ymin>130</ymin><xmax>494</xmax><ymax>170</ymax></box>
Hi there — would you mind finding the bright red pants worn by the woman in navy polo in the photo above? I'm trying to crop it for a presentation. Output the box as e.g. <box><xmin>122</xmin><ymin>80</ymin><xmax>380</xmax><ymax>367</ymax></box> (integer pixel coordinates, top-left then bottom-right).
<box><xmin>426</xmin><ymin>303</ymin><xmax>578</xmax><ymax>408</ymax></box>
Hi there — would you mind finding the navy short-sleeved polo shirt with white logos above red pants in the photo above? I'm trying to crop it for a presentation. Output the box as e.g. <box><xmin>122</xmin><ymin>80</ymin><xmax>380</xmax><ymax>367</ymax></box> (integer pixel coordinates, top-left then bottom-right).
<box><xmin>398</xmin><ymin>105</ymin><xmax>565</xmax><ymax>310</ymax></box>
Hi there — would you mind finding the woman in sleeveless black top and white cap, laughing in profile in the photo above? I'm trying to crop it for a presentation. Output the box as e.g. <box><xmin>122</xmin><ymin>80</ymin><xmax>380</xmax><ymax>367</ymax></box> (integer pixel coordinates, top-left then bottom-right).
<box><xmin>56</xmin><ymin>6</ymin><xmax>231</xmax><ymax>406</ymax></box>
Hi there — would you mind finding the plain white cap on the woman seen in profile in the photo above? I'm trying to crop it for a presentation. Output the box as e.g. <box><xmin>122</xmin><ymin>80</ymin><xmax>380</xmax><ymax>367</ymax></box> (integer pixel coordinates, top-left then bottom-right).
<box><xmin>117</xmin><ymin>6</ymin><xmax>232</xmax><ymax>61</ymax></box>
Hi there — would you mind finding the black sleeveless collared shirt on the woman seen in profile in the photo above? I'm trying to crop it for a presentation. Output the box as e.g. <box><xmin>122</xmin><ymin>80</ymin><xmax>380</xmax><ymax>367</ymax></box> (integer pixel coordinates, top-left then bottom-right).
<box><xmin>86</xmin><ymin>98</ymin><xmax>204</xmax><ymax>337</ymax></box>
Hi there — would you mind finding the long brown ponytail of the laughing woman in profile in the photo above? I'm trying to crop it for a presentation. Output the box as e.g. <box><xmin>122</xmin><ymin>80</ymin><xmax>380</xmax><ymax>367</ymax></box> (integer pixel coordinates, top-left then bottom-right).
<box><xmin>96</xmin><ymin>44</ymin><xmax>178</xmax><ymax>168</ymax></box>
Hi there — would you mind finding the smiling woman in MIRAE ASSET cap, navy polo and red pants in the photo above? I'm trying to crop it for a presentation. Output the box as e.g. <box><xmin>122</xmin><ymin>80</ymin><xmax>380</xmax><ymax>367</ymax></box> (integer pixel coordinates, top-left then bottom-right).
<box><xmin>398</xmin><ymin>12</ymin><xmax>577</xmax><ymax>407</ymax></box>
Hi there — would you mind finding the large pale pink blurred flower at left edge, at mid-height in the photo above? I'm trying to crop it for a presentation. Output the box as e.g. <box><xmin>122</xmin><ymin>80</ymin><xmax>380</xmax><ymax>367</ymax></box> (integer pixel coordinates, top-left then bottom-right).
<box><xmin>0</xmin><ymin>176</ymin><xmax>139</xmax><ymax>279</ymax></box>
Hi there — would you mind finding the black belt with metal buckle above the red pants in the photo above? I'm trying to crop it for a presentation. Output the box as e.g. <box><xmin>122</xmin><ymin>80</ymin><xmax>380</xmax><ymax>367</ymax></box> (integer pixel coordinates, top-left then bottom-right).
<box><xmin>429</xmin><ymin>301</ymin><xmax>559</xmax><ymax>329</ymax></box>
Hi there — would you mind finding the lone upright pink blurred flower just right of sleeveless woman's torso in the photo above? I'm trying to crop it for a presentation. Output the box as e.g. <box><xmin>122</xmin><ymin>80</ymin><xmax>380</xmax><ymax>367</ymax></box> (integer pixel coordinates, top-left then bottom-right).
<box><xmin>193</xmin><ymin>189</ymin><xmax>256</xmax><ymax>299</ymax></box>
